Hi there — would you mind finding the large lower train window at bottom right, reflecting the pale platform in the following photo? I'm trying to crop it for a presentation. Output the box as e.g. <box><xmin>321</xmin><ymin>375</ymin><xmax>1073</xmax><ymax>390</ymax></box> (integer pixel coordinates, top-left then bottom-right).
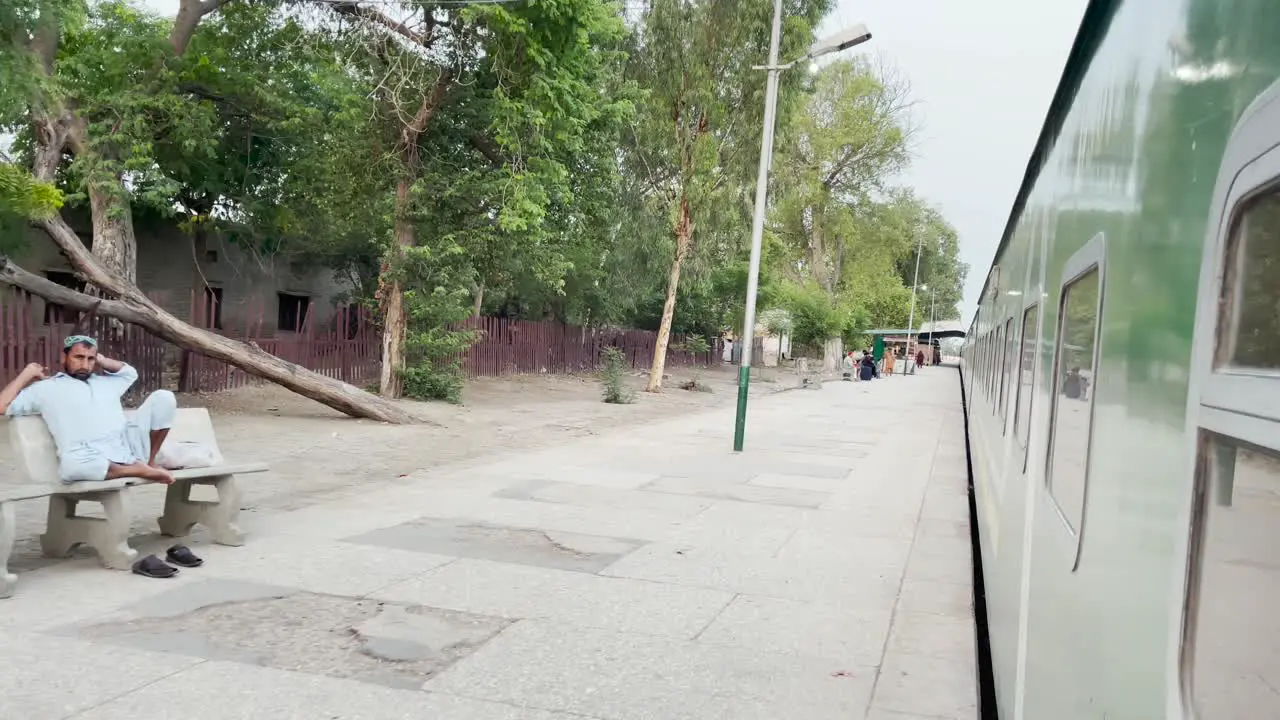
<box><xmin>1181</xmin><ymin>432</ymin><xmax>1280</xmax><ymax>720</ymax></box>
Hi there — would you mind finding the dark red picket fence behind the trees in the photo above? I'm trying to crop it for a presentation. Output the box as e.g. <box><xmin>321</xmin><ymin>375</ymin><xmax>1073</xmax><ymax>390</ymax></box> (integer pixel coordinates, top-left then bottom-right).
<box><xmin>0</xmin><ymin>287</ymin><xmax>722</xmax><ymax>402</ymax></box>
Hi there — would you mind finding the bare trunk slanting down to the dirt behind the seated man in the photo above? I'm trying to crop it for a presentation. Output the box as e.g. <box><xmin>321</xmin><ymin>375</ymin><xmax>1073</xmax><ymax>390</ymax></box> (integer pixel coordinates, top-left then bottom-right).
<box><xmin>0</xmin><ymin>249</ymin><xmax>415</xmax><ymax>423</ymax></box>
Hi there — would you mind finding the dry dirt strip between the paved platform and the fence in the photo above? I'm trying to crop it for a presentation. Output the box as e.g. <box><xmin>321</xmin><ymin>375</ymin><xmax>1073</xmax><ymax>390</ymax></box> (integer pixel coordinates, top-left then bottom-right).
<box><xmin>0</xmin><ymin>366</ymin><xmax>799</xmax><ymax>571</ymax></box>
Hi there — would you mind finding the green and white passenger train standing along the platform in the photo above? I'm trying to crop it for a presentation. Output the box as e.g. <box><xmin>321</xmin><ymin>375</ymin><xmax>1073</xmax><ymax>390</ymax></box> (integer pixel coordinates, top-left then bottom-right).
<box><xmin>961</xmin><ymin>0</ymin><xmax>1280</xmax><ymax>720</ymax></box>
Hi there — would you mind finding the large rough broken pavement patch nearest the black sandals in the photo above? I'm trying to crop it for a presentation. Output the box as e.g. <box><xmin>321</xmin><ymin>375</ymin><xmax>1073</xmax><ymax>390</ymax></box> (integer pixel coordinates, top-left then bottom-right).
<box><xmin>76</xmin><ymin>580</ymin><xmax>512</xmax><ymax>689</ymax></box>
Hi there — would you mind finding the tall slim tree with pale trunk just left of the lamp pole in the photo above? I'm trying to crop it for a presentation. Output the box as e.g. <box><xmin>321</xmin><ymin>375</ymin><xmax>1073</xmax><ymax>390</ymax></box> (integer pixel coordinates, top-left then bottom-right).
<box><xmin>626</xmin><ymin>0</ymin><xmax>829</xmax><ymax>392</ymax></box>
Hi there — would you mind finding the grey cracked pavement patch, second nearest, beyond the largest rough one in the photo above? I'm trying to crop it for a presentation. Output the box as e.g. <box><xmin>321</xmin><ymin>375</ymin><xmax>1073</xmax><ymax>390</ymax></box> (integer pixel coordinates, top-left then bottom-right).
<box><xmin>346</xmin><ymin>518</ymin><xmax>646</xmax><ymax>573</ymax></box>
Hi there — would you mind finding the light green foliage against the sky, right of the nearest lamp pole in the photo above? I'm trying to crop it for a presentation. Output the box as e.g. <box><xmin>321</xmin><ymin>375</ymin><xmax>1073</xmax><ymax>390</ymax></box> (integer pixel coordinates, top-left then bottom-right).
<box><xmin>765</xmin><ymin>60</ymin><xmax>968</xmax><ymax>333</ymax></box>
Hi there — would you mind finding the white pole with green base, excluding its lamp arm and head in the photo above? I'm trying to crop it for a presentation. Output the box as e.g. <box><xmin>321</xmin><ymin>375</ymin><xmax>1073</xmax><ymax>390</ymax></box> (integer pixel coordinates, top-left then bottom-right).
<box><xmin>733</xmin><ymin>0</ymin><xmax>782</xmax><ymax>452</ymax></box>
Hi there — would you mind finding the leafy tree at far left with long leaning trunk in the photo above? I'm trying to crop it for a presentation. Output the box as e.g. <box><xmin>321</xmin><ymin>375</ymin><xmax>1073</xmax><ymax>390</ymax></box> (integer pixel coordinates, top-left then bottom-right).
<box><xmin>0</xmin><ymin>0</ymin><xmax>411</xmax><ymax>421</ymax></box>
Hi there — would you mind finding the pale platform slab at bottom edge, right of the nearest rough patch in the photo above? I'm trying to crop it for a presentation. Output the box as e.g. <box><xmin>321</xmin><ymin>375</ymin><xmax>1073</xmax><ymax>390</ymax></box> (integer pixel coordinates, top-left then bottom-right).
<box><xmin>426</xmin><ymin>621</ymin><xmax>874</xmax><ymax>720</ymax></box>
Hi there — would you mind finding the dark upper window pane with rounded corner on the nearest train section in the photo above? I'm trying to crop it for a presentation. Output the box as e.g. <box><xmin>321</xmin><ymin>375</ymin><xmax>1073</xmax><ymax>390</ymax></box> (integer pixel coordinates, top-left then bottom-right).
<box><xmin>1220</xmin><ymin>187</ymin><xmax>1280</xmax><ymax>370</ymax></box>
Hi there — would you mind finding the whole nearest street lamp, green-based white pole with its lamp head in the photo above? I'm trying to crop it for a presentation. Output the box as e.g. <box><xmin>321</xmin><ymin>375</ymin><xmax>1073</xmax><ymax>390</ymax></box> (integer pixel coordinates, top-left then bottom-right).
<box><xmin>733</xmin><ymin>11</ymin><xmax>872</xmax><ymax>452</ymax></box>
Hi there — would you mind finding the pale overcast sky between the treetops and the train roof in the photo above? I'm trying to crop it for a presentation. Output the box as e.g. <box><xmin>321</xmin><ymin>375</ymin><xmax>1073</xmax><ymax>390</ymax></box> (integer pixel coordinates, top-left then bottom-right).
<box><xmin>140</xmin><ymin>0</ymin><xmax>1085</xmax><ymax>323</ymax></box>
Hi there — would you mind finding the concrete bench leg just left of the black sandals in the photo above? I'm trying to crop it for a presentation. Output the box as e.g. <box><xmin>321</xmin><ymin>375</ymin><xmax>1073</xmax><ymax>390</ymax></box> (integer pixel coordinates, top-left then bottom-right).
<box><xmin>40</xmin><ymin>488</ymin><xmax>138</xmax><ymax>570</ymax></box>
